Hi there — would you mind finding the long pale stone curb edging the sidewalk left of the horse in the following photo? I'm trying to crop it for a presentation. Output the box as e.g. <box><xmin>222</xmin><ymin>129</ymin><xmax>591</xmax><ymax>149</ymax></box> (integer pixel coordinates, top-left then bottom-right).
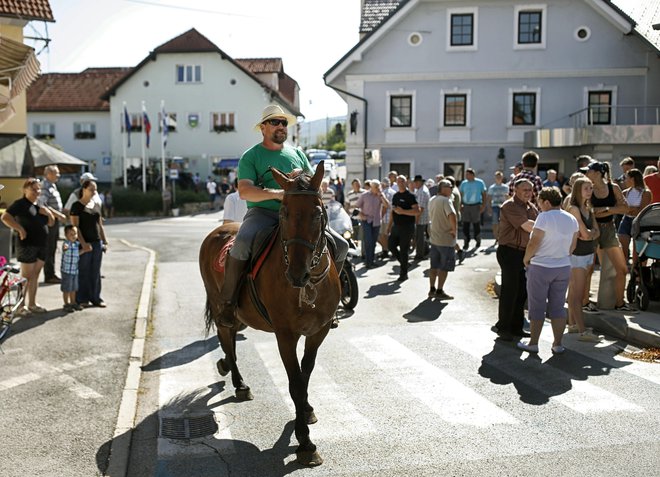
<box><xmin>104</xmin><ymin>239</ymin><xmax>156</xmax><ymax>477</ymax></box>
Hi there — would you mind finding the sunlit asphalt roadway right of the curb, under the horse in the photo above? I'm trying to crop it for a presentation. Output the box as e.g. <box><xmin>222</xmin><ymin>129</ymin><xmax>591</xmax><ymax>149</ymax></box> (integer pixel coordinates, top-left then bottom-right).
<box><xmin>109</xmin><ymin>213</ymin><xmax>660</xmax><ymax>476</ymax></box>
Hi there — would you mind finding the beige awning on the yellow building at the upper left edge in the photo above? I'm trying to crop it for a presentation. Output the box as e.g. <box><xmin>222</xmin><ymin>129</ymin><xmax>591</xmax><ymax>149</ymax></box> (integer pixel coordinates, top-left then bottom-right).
<box><xmin>0</xmin><ymin>36</ymin><xmax>39</xmax><ymax>124</ymax></box>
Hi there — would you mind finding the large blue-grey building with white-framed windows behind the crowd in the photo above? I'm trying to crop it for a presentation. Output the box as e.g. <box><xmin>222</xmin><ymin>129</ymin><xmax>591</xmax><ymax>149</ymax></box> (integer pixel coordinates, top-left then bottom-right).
<box><xmin>324</xmin><ymin>0</ymin><xmax>660</xmax><ymax>185</ymax></box>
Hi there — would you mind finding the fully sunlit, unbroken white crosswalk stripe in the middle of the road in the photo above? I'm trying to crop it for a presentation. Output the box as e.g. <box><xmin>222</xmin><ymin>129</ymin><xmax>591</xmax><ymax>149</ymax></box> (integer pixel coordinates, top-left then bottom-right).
<box><xmin>349</xmin><ymin>336</ymin><xmax>518</xmax><ymax>427</ymax></box>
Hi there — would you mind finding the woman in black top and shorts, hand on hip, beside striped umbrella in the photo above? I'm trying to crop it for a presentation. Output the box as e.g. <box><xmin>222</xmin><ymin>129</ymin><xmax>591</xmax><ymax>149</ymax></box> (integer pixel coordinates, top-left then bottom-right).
<box><xmin>2</xmin><ymin>177</ymin><xmax>55</xmax><ymax>313</ymax></box>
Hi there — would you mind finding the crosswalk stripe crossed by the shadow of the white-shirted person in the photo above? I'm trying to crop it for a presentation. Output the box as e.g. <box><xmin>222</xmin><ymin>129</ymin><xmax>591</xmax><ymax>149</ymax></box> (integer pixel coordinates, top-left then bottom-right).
<box><xmin>431</xmin><ymin>325</ymin><xmax>643</xmax><ymax>414</ymax></box>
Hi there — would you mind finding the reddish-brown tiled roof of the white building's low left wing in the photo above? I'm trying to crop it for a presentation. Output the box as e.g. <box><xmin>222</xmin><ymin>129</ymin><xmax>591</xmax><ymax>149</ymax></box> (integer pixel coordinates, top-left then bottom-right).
<box><xmin>27</xmin><ymin>68</ymin><xmax>133</xmax><ymax>111</ymax></box>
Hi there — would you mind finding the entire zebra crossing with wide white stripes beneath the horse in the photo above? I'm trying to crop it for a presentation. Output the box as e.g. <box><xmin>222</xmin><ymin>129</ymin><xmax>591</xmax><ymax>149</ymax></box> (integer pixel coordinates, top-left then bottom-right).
<box><xmin>153</xmin><ymin>322</ymin><xmax>660</xmax><ymax>458</ymax></box>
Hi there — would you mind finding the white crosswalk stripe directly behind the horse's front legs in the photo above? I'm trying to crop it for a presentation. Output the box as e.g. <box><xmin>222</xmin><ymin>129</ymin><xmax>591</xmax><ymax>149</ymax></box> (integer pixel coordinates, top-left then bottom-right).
<box><xmin>255</xmin><ymin>340</ymin><xmax>374</xmax><ymax>439</ymax></box>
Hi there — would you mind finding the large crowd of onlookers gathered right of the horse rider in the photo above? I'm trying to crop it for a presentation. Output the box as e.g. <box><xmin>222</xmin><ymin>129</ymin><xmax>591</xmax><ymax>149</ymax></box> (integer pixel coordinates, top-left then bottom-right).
<box><xmin>336</xmin><ymin>151</ymin><xmax>660</xmax><ymax>353</ymax></box>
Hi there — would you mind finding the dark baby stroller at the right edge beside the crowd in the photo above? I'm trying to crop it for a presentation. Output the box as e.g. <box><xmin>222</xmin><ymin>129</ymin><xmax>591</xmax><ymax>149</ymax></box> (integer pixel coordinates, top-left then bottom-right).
<box><xmin>626</xmin><ymin>203</ymin><xmax>660</xmax><ymax>310</ymax></box>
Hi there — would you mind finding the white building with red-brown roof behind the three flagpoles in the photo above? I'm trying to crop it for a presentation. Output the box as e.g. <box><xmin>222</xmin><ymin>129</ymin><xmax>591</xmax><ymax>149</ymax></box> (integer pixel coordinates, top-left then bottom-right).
<box><xmin>28</xmin><ymin>29</ymin><xmax>302</xmax><ymax>186</ymax></box>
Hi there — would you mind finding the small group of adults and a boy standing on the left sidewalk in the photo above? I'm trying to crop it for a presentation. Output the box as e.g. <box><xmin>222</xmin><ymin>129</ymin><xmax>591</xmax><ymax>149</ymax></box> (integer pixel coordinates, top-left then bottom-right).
<box><xmin>2</xmin><ymin>165</ymin><xmax>111</xmax><ymax>315</ymax></box>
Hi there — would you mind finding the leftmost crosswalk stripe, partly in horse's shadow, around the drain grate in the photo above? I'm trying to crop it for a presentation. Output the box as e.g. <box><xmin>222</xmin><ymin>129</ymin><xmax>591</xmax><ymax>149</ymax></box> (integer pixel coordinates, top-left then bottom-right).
<box><xmin>158</xmin><ymin>349</ymin><xmax>236</xmax><ymax>457</ymax></box>
